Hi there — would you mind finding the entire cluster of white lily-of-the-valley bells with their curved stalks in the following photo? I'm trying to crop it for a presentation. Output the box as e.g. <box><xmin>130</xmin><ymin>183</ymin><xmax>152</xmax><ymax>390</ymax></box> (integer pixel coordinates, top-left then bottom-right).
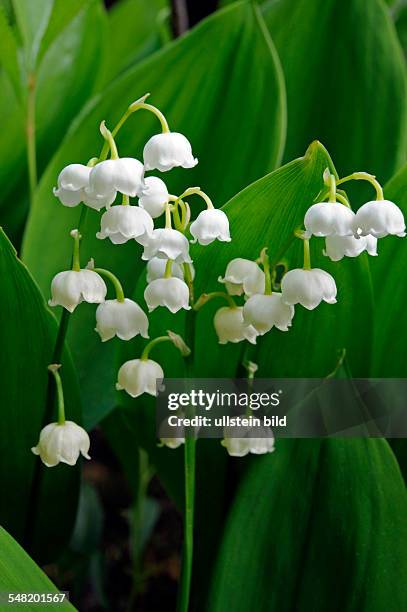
<box><xmin>33</xmin><ymin>96</ymin><xmax>405</xmax><ymax>466</ymax></box>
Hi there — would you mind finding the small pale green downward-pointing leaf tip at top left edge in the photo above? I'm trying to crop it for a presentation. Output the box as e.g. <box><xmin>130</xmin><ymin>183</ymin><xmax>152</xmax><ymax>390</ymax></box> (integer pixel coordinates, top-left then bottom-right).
<box><xmin>13</xmin><ymin>0</ymin><xmax>54</xmax><ymax>72</ymax></box>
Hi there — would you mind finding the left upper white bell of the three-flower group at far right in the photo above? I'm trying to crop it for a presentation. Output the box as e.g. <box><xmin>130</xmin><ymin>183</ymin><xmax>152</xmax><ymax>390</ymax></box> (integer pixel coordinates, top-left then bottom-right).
<box><xmin>304</xmin><ymin>202</ymin><xmax>355</xmax><ymax>236</ymax></box>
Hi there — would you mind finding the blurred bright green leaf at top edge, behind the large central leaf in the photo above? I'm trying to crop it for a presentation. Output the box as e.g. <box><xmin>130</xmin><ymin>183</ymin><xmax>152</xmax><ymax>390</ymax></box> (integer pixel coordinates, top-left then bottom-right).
<box><xmin>99</xmin><ymin>0</ymin><xmax>167</xmax><ymax>84</ymax></box>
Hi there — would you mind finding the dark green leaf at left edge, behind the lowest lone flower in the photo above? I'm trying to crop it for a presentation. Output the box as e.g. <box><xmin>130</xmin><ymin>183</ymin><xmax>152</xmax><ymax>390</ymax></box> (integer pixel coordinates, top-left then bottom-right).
<box><xmin>0</xmin><ymin>232</ymin><xmax>81</xmax><ymax>561</ymax></box>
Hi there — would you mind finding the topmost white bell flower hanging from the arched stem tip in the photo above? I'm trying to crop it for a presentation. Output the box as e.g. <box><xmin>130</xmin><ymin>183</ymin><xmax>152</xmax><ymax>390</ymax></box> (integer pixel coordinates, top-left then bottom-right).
<box><xmin>143</xmin><ymin>132</ymin><xmax>198</xmax><ymax>172</ymax></box>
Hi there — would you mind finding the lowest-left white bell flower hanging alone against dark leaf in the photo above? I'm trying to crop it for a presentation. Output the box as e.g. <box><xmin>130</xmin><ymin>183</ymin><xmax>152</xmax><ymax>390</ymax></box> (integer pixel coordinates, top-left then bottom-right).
<box><xmin>31</xmin><ymin>421</ymin><xmax>90</xmax><ymax>467</ymax></box>
